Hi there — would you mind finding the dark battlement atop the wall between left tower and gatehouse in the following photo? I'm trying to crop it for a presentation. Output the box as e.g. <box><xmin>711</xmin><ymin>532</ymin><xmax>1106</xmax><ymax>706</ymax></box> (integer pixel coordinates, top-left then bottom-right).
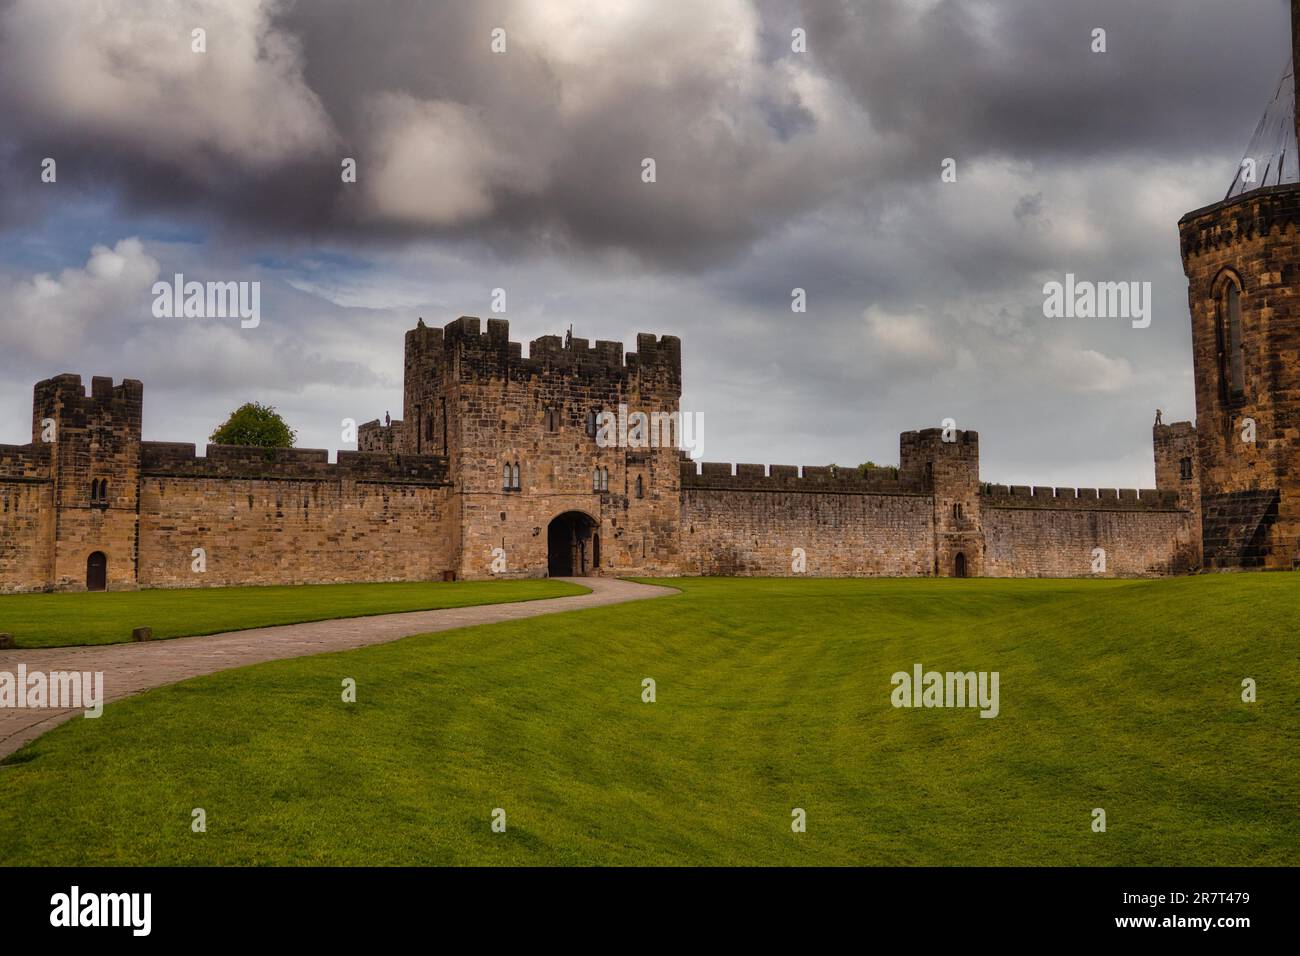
<box><xmin>140</xmin><ymin>441</ymin><xmax>450</xmax><ymax>485</ymax></box>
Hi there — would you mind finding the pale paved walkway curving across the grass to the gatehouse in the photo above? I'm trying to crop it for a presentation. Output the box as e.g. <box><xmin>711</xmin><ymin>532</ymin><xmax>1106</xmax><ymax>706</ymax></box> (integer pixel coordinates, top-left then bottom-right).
<box><xmin>0</xmin><ymin>578</ymin><xmax>677</xmax><ymax>757</ymax></box>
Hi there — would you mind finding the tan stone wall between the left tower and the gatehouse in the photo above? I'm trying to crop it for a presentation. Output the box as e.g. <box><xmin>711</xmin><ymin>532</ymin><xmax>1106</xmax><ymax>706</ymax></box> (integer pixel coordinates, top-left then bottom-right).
<box><xmin>139</xmin><ymin>442</ymin><xmax>455</xmax><ymax>588</ymax></box>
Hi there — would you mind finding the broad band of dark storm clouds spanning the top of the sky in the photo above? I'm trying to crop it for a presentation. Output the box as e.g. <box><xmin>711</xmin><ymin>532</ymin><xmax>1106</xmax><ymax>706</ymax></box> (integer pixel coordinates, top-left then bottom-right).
<box><xmin>0</xmin><ymin>0</ymin><xmax>1284</xmax><ymax>268</ymax></box>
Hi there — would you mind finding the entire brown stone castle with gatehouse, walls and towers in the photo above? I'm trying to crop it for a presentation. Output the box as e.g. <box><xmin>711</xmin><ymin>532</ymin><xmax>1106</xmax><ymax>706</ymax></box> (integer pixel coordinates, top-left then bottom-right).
<box><xmin>0</xmin><ymin>16</ymin><xmax>1300</xmax><ymax>592</ymax></box>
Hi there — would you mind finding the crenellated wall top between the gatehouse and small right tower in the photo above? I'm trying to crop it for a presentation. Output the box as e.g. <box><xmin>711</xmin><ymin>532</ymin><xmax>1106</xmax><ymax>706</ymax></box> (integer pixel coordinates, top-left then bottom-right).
<box><xmin>681</xmin><ymin>460</ymin><xmax>928</xmax><ymax>494</ymax></box>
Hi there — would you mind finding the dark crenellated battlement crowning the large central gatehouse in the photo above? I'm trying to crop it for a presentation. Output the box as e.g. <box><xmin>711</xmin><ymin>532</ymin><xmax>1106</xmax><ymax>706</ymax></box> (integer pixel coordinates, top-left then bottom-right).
<box><xmin>406</xmin><ymin>316</ymin><xmax>681</xmax><ymax>389</ymax></box>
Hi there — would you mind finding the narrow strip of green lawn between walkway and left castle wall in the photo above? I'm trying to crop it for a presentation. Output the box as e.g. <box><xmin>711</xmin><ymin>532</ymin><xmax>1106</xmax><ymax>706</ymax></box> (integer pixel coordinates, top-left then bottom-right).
<box><xmin>0</xmin><ymin>580</ymin><xmax>586</xmax><ymax>648</ymax></box>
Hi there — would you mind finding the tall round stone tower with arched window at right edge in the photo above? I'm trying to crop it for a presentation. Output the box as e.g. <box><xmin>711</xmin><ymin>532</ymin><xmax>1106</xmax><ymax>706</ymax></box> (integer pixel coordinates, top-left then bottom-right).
<box><xmin>1178</xmin><ymin>0</ymin><xmax>1300</xmax><ymax>570</ymax></box>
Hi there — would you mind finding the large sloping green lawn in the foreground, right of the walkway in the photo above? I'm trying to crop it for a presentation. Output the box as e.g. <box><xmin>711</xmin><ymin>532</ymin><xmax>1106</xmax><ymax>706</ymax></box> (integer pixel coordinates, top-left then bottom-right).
<box><xmin>0</xmin><ymin>574</ymin><xmax>1300</xmax><ymax>865</ymax></box>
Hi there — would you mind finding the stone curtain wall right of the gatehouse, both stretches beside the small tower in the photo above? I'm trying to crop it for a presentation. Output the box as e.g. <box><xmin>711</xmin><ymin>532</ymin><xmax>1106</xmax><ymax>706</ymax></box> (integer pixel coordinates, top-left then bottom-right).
<box><xmin>681</xmin><ymin>463</ymin><xmax>1197</xmax><ymax>578</ymax></box>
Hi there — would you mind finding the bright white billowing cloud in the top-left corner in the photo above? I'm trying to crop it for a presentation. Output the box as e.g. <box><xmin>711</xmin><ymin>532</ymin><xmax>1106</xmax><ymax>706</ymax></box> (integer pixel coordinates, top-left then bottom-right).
<box><xmin>0</xmin><ymin>0</ymin><xmax>334</xmax><ymax>169</ymax></box>
